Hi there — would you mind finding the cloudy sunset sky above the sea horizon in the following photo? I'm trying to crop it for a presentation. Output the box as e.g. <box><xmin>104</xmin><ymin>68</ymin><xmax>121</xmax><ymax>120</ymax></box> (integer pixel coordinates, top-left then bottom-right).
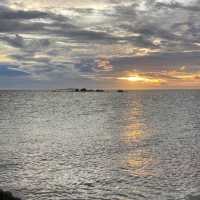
<box><xmin>0</xmin><ymin>0</ymin><xmax>200</xmax><ymax>89</ymax></box>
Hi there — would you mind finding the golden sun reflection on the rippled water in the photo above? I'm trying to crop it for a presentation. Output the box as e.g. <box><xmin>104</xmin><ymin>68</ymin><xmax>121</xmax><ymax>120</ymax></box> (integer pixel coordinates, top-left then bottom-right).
<box><xmin>121</xmin><ymin>99</ymin><xmax>158</xmax><ymax>177</ymax></box>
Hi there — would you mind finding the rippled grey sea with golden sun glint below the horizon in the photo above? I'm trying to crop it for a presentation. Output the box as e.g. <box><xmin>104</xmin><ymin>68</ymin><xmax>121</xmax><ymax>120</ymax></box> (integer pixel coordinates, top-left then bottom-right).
<box><xmin>0</xmin><ymin>90</ymin><xmax>200</xmax><ymax>200</ymax></box>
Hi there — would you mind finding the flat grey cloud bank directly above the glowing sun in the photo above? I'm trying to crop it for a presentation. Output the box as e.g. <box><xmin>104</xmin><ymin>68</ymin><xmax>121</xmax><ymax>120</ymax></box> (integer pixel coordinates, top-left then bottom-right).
<box><xmin>111</xmin><ymin>52</ymin><xmax>200</xmax><ymax>71</ymax></box>
